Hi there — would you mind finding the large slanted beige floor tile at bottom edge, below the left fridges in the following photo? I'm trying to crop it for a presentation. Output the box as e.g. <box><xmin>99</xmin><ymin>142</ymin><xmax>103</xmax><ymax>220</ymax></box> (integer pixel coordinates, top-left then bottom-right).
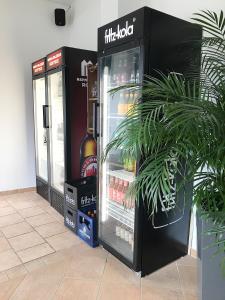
<box><xmin>10</xmin><ymin>258</ymin><xmax>66</xmax><ymax>300</ymax></box>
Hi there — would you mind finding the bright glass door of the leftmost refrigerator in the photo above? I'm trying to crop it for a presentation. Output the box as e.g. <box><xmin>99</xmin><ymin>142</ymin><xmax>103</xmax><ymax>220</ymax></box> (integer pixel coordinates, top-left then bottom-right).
<box><xmin>33</xmin><ymin>78</ymin><xmax>48</xmax><ymax>181</ymax></box>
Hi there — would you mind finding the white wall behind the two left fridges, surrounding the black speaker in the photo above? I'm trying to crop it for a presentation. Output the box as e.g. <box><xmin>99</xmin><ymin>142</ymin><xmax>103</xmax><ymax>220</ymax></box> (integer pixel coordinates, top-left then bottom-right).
<box><xmin>0</xmin><ymin>0</ymin><xmax>100</xmax><ymax>191</ymax></box>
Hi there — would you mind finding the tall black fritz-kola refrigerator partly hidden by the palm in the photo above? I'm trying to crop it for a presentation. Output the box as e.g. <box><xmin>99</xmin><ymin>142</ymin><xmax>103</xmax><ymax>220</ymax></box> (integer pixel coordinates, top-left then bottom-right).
<box><xmin>96</xmin><ymin>7</ymin><xmax>201</xmax><ymax>276</ymax></box>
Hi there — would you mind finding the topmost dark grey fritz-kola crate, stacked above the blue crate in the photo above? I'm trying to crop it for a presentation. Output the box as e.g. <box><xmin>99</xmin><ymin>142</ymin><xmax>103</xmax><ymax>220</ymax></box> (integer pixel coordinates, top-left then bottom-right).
<box><xmin>64</xmin><ymin>176</ymin><xmax>96</xmax><ymax>211</ymax></box>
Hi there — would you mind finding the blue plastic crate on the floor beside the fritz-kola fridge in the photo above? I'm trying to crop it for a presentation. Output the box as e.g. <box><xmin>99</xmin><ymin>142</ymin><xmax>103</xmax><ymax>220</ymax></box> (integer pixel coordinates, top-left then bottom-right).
<box><xmin>77</xmin><ymin>210</ymin><xmax>99</xmax><ymax>247</ymax></box>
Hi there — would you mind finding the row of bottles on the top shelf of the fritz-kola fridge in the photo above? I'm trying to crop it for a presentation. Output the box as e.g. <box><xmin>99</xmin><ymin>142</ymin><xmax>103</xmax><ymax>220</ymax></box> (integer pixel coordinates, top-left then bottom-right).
<box><xmin>111</xmin><ymin>57</ymin><xmax>140</xmax><ymax>86</ymax></box>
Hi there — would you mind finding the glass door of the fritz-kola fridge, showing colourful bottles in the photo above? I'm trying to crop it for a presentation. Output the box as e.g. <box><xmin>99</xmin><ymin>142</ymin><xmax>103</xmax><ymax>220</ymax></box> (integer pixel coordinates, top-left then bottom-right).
<box><xmin>99</xmin><ymin>47</ymin><xmax>140</xmax><ymax>263</ymax></box>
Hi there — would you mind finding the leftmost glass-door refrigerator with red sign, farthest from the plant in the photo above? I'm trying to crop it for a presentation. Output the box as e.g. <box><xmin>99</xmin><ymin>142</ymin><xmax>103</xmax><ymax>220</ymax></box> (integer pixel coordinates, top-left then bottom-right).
<box><xmin>32</xmin><ymin>58</ymin><xmax>49</xmax><ymax>200</ymax></box>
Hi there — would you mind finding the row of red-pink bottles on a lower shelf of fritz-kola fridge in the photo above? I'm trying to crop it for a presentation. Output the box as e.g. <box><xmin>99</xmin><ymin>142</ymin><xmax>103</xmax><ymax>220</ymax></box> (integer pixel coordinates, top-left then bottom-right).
<box><xmin>109</xmin><ymin>176</ymin><xmax>134</xmax><ymax>208</ymax></box>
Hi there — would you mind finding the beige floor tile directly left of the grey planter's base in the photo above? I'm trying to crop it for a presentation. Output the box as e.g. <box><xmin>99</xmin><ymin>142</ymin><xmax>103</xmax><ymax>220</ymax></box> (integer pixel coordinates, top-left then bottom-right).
<box><xmin>179</xmin><ymin>266</ymin><xmax>198</xmax><ymax>296</ymax></box>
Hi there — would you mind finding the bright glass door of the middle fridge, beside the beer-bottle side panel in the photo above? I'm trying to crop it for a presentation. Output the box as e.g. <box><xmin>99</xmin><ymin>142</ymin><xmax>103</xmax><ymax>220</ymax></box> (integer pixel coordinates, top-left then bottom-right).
<box><xmin>48</xmin><ymin>71</ymin><xmax>64</xmax><ymax>193</ymax></box>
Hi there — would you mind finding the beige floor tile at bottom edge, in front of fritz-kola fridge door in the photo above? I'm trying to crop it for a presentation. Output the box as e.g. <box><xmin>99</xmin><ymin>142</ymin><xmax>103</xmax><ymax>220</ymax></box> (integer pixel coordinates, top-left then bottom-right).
<box><xmin>98</xmin><ymin>282</ymin><xmax>140</xmax><ymax>300</ymax></box>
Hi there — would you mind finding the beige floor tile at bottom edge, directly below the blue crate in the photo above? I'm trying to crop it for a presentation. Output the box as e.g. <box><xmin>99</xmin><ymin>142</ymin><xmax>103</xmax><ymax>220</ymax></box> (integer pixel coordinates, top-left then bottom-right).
<box><xmin>54</xmin><ymin>278</ymin><xmax>99</xmax><ymax>300</ymax></box>
